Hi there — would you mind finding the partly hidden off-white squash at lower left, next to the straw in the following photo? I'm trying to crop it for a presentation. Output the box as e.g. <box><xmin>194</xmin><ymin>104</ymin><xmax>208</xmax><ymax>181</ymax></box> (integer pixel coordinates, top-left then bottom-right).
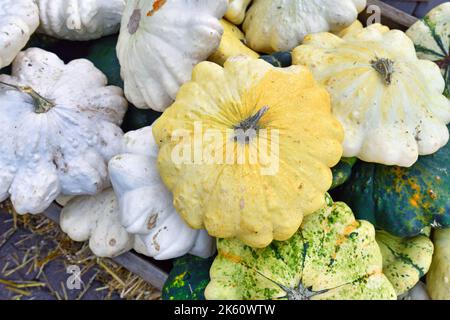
<box><xmin>60</xmin><ymin>188</ymin><xmax>134</xmax><ymax>257</ymax></box>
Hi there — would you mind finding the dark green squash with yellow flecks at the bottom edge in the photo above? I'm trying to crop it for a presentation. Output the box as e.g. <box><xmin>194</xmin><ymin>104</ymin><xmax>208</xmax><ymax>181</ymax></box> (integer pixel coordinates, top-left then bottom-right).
<box><xmin>162</xmin><ymin>255</ymin><xmax>214</xmax><ymax>300</ymax></box>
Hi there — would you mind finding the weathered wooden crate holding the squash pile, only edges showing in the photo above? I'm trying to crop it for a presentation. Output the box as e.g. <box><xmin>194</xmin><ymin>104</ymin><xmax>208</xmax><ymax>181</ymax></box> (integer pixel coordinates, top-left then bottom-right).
<box><xmin>40</xmin><ymin>0</ymin><xmax>424</xmax><ymax>290</ymax></box>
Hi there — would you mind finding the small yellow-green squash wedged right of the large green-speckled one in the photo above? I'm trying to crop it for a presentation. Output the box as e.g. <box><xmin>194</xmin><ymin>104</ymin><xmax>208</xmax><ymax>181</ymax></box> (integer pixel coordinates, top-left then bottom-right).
<box><xmin>376</xmin><ymin>230</ymin><xmax>433</xmax><ymax>296</ymax></box>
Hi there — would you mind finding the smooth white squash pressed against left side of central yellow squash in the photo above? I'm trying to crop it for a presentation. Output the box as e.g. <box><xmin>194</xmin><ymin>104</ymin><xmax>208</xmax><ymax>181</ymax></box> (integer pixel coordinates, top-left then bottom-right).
<box><xmin>109</xmin><ymin>127</ymin><xmax>215</xmax><ymax>260</ymax></box>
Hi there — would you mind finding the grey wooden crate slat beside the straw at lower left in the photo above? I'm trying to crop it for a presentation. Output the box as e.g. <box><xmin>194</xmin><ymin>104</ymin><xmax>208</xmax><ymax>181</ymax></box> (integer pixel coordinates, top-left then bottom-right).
<box><xmin>44</xmin><ymin>204</ymin><xmax>168</xmax><ymax>290</ymax></box>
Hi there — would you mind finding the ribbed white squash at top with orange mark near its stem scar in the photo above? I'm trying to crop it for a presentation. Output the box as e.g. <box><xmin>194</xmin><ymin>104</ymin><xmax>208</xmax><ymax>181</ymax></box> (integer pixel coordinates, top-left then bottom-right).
<box><xmin>117</xmin><ymin>0</ymin><xmax>228</xmax><ymax>111</ymax></box>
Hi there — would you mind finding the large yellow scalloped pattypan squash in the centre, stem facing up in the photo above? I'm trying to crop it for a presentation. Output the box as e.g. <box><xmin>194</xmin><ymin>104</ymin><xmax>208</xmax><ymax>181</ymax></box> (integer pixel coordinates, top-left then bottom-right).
<box><xmin>153</xmin><ymin>56</ymin><xmax>343</xmax><ymax>247</ymax></box>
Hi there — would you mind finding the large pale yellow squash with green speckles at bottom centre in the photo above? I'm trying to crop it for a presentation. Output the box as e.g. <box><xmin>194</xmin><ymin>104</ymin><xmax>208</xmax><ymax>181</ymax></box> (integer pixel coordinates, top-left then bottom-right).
<box><xmin>205</xmin><ymin>197</ymin><xmax>397</xmax><ymax>300</ymax></box>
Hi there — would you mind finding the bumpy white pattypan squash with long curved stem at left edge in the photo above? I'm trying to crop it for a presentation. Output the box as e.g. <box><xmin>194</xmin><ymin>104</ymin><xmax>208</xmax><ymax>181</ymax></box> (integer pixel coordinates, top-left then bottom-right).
<box><xmin>0</xmin><ymin>48</ymin><xmax>127</xmax><ymax>214</ymax></box>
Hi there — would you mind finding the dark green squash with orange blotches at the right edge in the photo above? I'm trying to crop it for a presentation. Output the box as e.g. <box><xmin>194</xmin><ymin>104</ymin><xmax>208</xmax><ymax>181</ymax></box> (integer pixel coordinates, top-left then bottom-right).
<box><xmin>339</xmin><ymin>131</ymin><xmax>450</xmax><ymax>237</ymax></box>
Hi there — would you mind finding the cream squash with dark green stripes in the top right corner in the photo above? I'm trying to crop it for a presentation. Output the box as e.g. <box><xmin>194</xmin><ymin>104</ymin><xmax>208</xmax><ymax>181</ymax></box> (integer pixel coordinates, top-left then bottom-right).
<box><xmin>406</xmin><ymin>2</ymin><xmax>450</xmax><ymax>98</ymax></box>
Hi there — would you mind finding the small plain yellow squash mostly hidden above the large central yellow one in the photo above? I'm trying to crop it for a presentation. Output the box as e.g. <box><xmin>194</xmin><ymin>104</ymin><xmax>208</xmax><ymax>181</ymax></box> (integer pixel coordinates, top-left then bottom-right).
<box><xmin>208</xmin><ymin>19</ymin><xmax>259</xmax><ymax>66</ymax></box>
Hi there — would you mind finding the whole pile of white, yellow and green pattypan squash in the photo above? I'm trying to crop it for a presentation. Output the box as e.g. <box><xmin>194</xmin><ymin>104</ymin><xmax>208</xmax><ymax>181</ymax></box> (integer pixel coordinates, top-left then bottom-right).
<box><xmin>0</xmin><ymin>0</ymin><xmax>450</xmax><ymax>300</ymax></box>
